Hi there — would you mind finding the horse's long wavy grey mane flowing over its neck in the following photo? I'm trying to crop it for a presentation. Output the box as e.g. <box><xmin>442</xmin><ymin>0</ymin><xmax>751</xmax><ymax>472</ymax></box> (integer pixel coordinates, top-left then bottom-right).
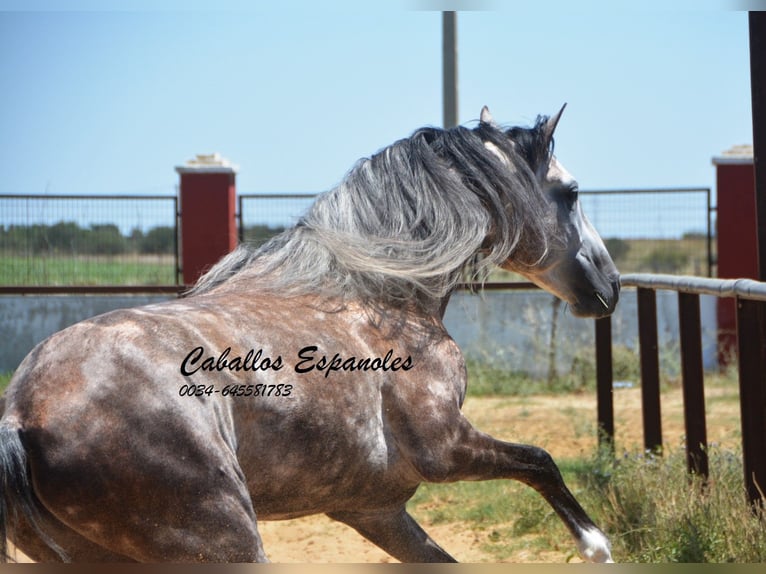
<box><xmin>189</xmin><ymin>117</ymin><xmax>554</xmax><ymax>304</ymax></box>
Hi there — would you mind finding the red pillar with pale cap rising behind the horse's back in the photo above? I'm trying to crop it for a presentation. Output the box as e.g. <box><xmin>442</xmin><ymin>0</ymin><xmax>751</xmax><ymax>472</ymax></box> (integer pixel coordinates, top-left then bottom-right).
<box><xmin>176</xmin><ymin>153</ymin><xmax>238</xmax><ymax>285</ymax></box>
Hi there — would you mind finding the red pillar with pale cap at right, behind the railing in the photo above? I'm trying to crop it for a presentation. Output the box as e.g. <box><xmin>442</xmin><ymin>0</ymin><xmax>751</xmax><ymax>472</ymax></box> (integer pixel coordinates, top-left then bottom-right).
<box><xmin>713</xmin><ymin>145</ymin><xmax>758</xmax><ymax>366</ymax></box>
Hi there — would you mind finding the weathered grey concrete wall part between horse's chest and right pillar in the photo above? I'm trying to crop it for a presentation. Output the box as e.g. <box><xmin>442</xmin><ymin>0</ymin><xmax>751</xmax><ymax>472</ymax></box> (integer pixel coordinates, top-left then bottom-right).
<box><xmin>445</xmin><ymin>290</ymin><xmax>717</xmax><ymax>382</ymax></box>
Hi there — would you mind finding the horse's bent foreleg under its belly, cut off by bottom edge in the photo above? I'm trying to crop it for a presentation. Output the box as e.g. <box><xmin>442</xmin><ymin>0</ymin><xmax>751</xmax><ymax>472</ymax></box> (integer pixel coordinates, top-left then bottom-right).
<box><xmin>328</xmin><ymin>507</ymin><xmax>456</xmax><ymax>562</ymax></box>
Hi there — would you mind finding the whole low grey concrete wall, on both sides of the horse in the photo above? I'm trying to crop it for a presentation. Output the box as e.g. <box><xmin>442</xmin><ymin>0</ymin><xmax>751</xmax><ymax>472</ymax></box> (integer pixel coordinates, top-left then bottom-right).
<box><xmin>0</xmin><ymin>291</ymin><xmax>716</xmax><ymax>376</ymax></box>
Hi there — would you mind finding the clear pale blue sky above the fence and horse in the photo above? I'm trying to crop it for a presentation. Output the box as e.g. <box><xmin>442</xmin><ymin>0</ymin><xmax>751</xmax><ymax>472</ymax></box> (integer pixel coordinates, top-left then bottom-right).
<box><xmin>0</xmin><ymin>0</ymin><xmax>752</xmax><ymax>213</ymax></box>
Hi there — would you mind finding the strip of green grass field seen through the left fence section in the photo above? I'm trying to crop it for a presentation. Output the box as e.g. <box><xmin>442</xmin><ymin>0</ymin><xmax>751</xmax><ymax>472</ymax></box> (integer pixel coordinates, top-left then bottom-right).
<box><xmin>0</xmin><ymin>255</ymin><xmax>176</xmax><ymax>286</ymax></box>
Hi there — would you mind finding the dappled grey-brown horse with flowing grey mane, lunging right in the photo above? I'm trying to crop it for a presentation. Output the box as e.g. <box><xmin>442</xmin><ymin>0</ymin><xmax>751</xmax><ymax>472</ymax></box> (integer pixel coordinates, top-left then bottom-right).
<box><xmin>0</xmin><ymin>107</ymin><xmax>619</xmax><ymax>562</ymax></box>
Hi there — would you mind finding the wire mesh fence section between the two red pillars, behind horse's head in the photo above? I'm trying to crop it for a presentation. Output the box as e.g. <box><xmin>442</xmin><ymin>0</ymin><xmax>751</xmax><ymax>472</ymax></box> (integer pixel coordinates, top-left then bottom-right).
<box><xmin>239</xmin><ymin>188</ymin><xmax>715</xmax><ymax>282</ymax></box>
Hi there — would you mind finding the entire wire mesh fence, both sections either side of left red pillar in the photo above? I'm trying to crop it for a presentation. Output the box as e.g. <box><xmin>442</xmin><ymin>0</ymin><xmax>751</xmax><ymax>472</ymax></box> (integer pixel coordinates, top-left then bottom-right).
<box><xmin>0</xmin><ymin>188</ymin><xmax>715</xmax><ymax>287</ymax></box>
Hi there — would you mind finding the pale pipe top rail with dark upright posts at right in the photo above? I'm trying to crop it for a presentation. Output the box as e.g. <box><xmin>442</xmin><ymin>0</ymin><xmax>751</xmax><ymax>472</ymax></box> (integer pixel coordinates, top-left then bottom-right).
<box><xmin>596</xmin><ymin>273</ymin><xmax>766</xmax><ymax>507</ymax></box>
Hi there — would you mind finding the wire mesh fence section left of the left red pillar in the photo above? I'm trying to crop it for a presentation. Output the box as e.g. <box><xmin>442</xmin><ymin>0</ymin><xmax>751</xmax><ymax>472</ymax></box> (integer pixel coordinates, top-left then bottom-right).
<box><xmin>0</xmin><ymin>195</ymin><xmax>179</xmax><ymax>287</ymax></box>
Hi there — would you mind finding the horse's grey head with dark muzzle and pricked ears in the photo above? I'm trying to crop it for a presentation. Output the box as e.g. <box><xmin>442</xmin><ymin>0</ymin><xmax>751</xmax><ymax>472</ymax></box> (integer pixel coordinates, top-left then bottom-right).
<box><xmin>481</xmin><ymin>107</ymin><xmax>620</xmax><ymax>317</ymax></box>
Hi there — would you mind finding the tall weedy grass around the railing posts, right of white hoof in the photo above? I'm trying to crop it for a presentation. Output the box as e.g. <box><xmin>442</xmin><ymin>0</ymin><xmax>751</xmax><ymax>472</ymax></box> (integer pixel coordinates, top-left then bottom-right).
<box><xmin>580</xmin><ymin>449</ymin><xmax>766</xmax><ymax>563</ymax></box>
